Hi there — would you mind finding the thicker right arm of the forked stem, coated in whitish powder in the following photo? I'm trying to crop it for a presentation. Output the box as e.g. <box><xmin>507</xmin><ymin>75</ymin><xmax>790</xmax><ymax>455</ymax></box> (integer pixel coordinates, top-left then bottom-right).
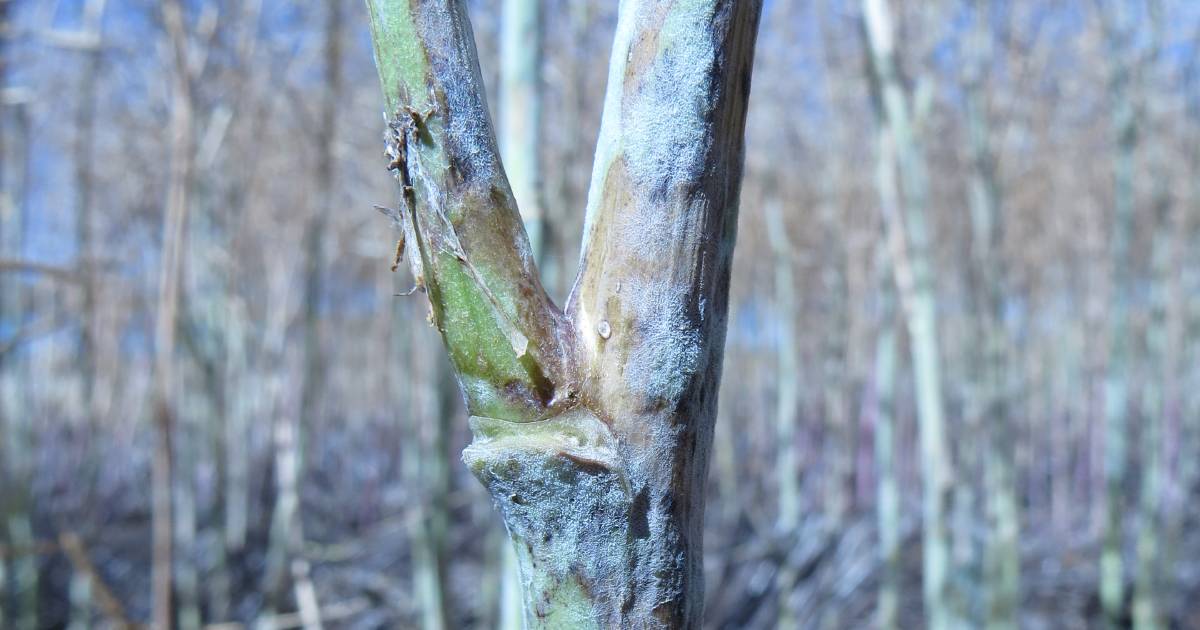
<box><xmin>568</xmin><ymin>0</ymin><xmax>761</xmax><ymax>432</ymax></box>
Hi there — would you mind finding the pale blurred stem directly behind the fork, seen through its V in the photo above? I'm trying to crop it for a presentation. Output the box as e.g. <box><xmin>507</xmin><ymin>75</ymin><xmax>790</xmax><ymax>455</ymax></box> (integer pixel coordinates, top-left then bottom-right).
<box><xmin>497</xmin><ymin>0</ymin><xmax>542</xmax><ymax>630</ymax></box>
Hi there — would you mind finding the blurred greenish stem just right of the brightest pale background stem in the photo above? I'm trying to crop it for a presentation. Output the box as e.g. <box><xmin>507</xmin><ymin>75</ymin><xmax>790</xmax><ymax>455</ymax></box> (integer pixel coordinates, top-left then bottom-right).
<box><xmin>965</xmin><ymin>0</ymin><xmax>1017</xmax><ymax>630</ymax></box>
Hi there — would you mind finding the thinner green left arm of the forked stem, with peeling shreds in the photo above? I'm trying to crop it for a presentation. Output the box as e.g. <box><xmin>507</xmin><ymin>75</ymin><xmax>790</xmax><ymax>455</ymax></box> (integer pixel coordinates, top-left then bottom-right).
<box><xmin>367</xmin><ymin>0</ymin><xmax>574</xmax><ymax>421</ymax></box>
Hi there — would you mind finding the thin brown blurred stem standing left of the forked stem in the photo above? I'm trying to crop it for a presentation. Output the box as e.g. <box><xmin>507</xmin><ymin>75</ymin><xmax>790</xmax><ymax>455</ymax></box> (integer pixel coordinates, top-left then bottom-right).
<box><xmin>151</xmin><ymin>0</ymin><xmax>194</xmax><ymax>630</ymax></box>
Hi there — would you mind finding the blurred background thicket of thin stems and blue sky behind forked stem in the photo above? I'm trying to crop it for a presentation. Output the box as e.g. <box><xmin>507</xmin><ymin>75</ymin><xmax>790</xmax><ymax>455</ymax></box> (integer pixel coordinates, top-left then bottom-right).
<box><xmin>0</xmin><ymin>0</ymin><xmax>1200</xmax><ymax>630</ymax></box>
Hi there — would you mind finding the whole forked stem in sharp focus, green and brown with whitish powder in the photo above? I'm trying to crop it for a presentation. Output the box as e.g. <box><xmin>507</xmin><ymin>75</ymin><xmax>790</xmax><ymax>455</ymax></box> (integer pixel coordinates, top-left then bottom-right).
<box><xmin>367</xmin><ymin>0</ymin><xmax>762</xmax><ymax>628</ymax></box>
